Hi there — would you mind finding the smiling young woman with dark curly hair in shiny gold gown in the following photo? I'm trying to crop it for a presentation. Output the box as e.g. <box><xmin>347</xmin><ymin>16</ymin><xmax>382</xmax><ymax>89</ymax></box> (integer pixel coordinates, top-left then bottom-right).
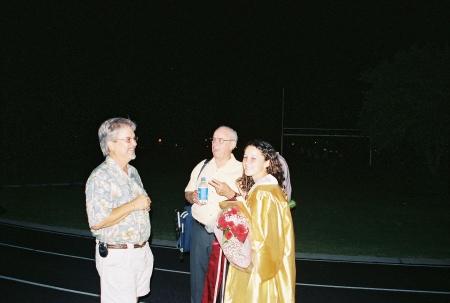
<box><xmin>224</xmin><ymin>140</ymin><xmax>295</xmax><ymax>303</ymax></box>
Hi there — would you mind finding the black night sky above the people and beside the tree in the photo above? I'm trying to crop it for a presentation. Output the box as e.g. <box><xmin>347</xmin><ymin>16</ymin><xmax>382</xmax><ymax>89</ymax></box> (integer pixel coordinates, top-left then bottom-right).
<box><xmin>0</xmin><ymin>0</ymin><xmax>450</xmax><ymax>177</ymax></box>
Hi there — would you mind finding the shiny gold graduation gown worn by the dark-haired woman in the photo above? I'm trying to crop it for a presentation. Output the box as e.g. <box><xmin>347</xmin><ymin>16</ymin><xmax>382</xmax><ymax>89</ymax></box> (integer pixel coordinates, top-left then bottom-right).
<box><xmin>224</xmin><ymin>179</ymin><xmax>295</xmax><ymax>303</ymax></box>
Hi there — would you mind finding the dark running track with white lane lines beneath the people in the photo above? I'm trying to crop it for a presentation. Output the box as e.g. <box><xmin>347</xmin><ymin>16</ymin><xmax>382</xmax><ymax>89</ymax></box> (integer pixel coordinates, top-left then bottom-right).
<box><xmin>0</xmin><ymin>222</ymin><xmax>450</xmax><ymax>303</ymax></box>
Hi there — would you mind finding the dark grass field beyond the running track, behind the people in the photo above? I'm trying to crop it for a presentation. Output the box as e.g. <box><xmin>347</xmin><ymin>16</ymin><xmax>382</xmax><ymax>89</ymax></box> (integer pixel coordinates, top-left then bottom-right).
<box><xmin>0</xmin><ymin>162</ymin><xmax>450</xmax><ymax>259</ymax></box>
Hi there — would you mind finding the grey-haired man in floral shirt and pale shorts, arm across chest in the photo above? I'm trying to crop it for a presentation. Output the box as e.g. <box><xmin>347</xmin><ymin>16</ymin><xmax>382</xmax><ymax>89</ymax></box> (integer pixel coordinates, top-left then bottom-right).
<box><xmin>86</xmin><ymin>118</ymin><xmax>153</xmax><ymax>303</ymax></box>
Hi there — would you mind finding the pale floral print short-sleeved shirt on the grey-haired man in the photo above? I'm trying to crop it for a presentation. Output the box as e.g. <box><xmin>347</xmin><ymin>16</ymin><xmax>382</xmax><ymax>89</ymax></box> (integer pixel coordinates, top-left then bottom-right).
<box><xmin>85</xmin><ymin>157</ymin><xmax>151</xmax><ymax>244</ymax></box>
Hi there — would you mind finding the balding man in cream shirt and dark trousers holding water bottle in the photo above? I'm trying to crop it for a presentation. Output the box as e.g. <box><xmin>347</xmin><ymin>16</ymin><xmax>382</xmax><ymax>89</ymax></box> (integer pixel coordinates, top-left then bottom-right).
<box><xmin>185</xmin><ymin>126</ymin><xmax>242</xmax><ymax>303</ymax></box>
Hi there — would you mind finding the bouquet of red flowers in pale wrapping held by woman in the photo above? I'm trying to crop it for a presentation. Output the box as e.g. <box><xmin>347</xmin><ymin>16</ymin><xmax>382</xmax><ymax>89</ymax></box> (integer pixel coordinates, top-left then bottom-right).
<box><xmin>214</xmin><ymin>202</ymin><xmax>252</xmax><ymax>269</ymax></box>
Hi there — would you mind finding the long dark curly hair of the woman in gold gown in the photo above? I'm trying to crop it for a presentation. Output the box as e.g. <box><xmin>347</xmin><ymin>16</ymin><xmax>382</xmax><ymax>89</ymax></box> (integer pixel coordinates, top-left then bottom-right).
<box><xmin>237</xmin><ymin>140</ymin><xmax>285</xmax><ymax>198</ymax></box>
